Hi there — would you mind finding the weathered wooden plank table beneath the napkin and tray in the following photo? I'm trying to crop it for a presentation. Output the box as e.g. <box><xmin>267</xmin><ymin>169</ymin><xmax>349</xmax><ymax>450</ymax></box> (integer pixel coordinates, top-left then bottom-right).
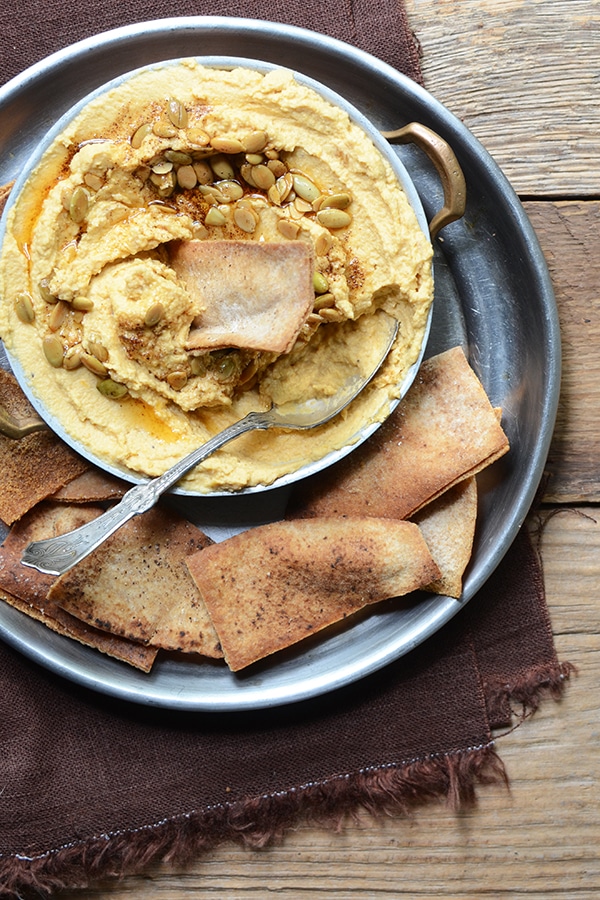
<box><xmin>60</xmin><ymin>0</ymin><xmax>600</xmax><ymax>900</ymax></box>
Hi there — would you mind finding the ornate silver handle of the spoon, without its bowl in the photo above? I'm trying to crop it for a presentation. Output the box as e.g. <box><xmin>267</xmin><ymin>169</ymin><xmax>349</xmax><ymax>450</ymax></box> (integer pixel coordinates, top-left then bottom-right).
<box><xmin>21</xmin><ymin>412</ymin><xmax>272</xmax><ymax>575</ymax></box>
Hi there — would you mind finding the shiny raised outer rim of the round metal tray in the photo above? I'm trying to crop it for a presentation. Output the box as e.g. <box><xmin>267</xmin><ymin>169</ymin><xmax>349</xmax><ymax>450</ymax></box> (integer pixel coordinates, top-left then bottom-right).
<box><xmin>0</xmin><ymin>16</ymin><xmax>561</xmax><ymax>712</ymax></box>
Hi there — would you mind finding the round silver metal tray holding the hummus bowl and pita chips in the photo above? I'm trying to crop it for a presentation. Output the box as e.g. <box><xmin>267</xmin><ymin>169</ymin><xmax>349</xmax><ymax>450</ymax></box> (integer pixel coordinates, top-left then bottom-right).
<box><xmin>0</xmin><ymin>17</ymin><xmax>560</xmax><ymax>712</ymax></box>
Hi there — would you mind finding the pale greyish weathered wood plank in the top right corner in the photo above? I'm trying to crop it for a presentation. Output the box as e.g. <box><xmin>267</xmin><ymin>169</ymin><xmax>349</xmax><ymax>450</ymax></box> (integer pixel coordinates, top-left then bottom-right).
<box><xmin>406</xmin><ymin>0</ymin><xmax>600</xmax><ymax>197</ymax></box>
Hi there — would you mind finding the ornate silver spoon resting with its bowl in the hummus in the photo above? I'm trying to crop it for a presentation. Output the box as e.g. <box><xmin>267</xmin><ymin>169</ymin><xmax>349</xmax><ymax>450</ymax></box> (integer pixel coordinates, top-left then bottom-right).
<box><xmin>21</xmin><ymin>313</ymin><xmax>398</xmax><ymax>575</ymax></box>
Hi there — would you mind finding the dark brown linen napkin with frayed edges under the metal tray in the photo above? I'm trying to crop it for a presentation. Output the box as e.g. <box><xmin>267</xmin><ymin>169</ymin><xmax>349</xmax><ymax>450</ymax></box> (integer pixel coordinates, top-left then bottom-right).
<box><xmin>0</xmin><ymin>0</ymin><xmax>569</xmax><ymax>898</ymax></box>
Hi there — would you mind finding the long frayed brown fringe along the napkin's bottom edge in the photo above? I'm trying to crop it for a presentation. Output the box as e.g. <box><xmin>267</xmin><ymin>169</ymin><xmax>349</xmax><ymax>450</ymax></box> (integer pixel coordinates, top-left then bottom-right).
<box><xmin>0</xmin><ymin>742</ymin><xmax>508</xmax><ymax>900</ymax></box>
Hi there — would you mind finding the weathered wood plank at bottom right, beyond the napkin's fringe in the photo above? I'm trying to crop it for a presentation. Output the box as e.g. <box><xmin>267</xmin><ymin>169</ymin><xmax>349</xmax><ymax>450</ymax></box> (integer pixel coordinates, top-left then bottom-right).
<box><xmin>52</xmin><ymin>509</ymin><xmax>600</xmax><ymax>900</ymax></box>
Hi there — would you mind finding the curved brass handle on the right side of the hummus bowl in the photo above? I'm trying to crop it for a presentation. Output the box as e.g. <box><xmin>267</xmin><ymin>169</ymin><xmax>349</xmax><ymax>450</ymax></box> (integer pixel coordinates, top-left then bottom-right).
<box><xmin>381</xmin><ymin>122</ymin><xmax>467</xmax><ymax>240</ymax></box>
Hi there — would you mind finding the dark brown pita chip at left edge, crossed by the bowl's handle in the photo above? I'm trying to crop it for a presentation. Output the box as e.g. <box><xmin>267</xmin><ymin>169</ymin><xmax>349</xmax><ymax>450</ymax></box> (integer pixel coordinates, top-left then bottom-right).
<box><xmin>0</xmin><ymin>369</ymin><xmax>89</xmax><ymax>525</ymax></box>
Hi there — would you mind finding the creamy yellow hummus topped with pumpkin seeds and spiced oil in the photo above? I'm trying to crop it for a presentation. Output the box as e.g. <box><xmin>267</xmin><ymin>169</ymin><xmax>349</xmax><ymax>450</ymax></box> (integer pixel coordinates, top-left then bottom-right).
<box><xmin>0</xmin><ymin>60</ymin><xmax>432</xmax><ymax>492</ymax></box>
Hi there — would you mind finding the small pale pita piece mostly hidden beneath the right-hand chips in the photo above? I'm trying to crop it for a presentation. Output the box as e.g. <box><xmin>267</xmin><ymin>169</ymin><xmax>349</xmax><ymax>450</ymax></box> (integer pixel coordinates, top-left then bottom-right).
<box><xmin>412</xmin><ymin>477</ymin><xmax>477</xmax><ymax>598</ymax></box>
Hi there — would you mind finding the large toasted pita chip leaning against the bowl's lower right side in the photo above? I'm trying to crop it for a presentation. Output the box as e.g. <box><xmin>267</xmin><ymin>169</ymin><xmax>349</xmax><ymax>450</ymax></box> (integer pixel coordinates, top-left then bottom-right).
<box><xmin>288</xmin><ymin>347</ymin><xmax>509</xmax><ymax>519</ymax></box>
